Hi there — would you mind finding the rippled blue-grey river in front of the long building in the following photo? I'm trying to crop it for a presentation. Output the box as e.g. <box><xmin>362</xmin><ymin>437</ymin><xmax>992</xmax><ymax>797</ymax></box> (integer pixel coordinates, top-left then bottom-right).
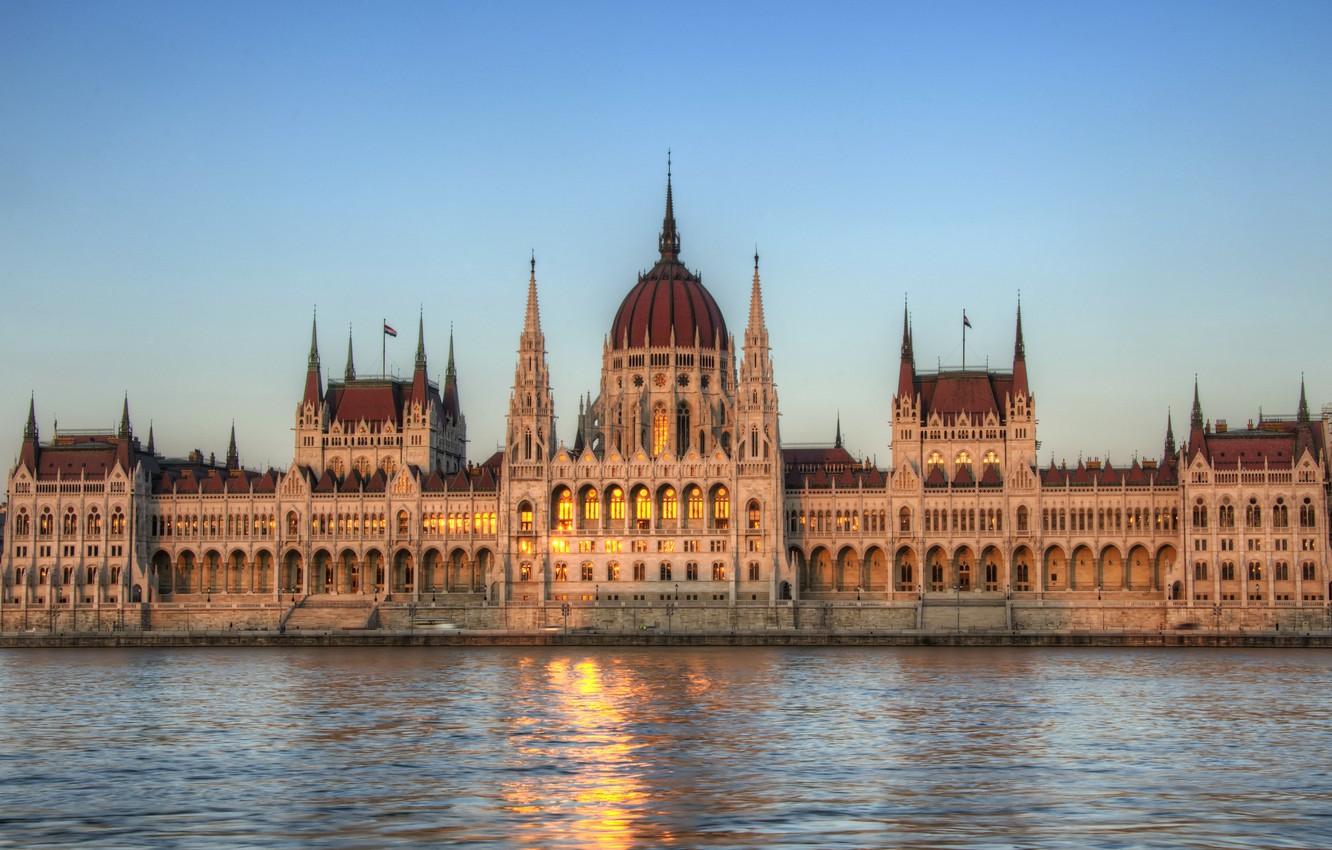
<box><xmin>0</xmin><ymin>647</ymin><xmax>1332</xmax><ymax>847</ymax></box>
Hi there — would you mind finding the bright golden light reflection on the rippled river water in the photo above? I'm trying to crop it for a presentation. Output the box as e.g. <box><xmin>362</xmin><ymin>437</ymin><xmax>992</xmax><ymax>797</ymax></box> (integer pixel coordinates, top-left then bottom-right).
<box><xmin>503</xmin><ymin>657</ymin><xmax>663</xmax><ymax>850</ymax></box>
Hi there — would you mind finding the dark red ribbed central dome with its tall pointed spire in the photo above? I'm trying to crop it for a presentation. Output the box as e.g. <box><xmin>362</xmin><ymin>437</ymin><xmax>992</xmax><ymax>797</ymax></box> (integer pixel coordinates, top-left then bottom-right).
<box><xmin>610</xmin><ymin>171</ymin><xmax>727</xmax><ymax>349</ymax></box>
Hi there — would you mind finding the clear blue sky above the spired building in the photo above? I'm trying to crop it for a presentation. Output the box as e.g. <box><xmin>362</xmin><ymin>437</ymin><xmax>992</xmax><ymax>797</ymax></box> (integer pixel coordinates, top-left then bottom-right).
<box><xmin>0</xmin><ymin>0</ymin><xmax>1332</xmax><ymax>466</ymax></box>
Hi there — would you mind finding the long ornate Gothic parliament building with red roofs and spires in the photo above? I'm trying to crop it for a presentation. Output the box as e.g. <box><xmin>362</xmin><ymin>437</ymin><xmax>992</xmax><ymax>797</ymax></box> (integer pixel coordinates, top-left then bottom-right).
<box><xmin>0</xmin><ymin>176</ymin><xmax>1332</xmax><ymax>630</ymax></box>
